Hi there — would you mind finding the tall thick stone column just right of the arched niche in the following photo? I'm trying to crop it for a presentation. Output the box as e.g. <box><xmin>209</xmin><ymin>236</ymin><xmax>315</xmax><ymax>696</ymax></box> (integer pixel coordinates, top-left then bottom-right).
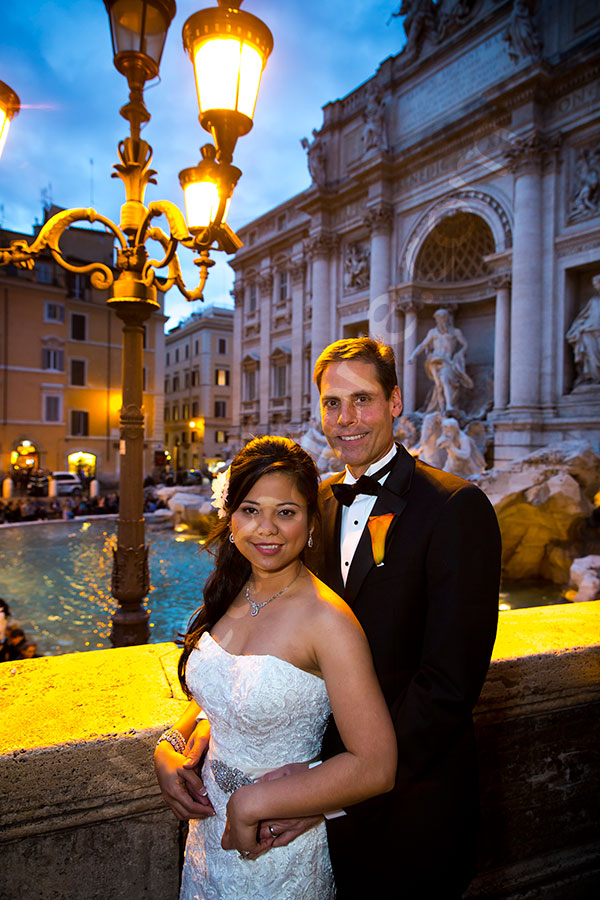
<box><xmin>506</xmin><ymin>133</ymin><xmax>545</xmax><ymax>411</ymax></box>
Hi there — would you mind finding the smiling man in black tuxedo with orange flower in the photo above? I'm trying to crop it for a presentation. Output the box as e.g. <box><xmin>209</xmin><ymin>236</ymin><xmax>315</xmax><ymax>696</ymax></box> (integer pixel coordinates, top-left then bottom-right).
<box><xmin>282</xmin><ymin>338</ymin><xmax>500</xmax><ymax>900</ymax></box>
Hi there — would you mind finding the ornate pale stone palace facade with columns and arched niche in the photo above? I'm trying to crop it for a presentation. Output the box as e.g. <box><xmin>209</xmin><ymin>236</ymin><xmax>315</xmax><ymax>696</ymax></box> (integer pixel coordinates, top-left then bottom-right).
<box><xmin>232</xmin><ymin>0</ymin><xmax>600</xmax><ymax>463</ymax></box>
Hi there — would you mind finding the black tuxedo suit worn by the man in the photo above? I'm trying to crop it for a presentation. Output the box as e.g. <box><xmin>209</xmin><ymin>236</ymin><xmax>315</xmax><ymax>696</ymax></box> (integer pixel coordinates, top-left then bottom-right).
<box><xmin>308</xmin><ymin>446</ymin><xmax>501</xmax><ymax>900</ymax></box>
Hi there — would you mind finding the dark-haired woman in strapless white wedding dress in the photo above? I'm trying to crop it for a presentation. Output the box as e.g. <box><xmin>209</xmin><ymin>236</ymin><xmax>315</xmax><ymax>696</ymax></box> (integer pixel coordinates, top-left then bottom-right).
<box><xmin>155</xmin><ymin>437</ymin><xmax>396</xmax><ymax>900</ymax></box>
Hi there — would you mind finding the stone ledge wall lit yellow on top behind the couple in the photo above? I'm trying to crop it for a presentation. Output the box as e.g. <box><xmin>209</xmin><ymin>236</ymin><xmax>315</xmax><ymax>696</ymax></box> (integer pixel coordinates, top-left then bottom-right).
<box><xmin>0</xmin><ymin>602</ymin><xmax>600</xmax><ymax>900</ymax></box>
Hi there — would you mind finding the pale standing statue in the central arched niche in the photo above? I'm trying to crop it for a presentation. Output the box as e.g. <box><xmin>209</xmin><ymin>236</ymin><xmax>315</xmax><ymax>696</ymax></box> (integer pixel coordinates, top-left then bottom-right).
<box><xmin>408</xmin><ymin>309</ymin><xmax>473</xmax><ymax>412</ymax></box>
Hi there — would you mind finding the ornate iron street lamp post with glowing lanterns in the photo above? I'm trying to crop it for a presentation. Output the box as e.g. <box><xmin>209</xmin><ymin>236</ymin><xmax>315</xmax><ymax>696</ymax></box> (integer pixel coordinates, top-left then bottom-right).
<box><xmin>0</xmin><ymin>0</ymin><xmax>273</xmax><ymax>647</ymax></box>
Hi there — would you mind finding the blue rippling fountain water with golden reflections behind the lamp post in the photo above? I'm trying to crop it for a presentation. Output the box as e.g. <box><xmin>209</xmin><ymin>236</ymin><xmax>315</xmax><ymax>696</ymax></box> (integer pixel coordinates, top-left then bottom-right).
<box><xmin>0</xmin><ymin>519</ymin><xmax>212</xmax><ymax>655</ymax></box>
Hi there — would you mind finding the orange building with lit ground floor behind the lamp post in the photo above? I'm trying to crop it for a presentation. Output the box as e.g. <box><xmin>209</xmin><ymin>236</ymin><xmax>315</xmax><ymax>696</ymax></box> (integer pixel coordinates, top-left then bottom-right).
<box><xmin>0</xmin><ymin>208</ymin><xmax>164</xmax><ymax>486</ymax></box>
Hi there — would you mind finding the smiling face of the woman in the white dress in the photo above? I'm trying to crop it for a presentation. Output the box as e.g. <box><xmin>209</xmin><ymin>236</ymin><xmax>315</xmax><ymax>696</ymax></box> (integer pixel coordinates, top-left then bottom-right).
<box><xmin>231</xmin><ymin>473</ymin><xmax>309</xmax><ymax>572</ymax></box>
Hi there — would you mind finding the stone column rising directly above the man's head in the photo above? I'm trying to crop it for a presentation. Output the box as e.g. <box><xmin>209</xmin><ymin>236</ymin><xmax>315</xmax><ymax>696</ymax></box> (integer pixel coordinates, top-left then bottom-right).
<box><xmin>366</xmin><ymin>204</ymin><xmax>397</xmax><ymax>346</ymax></box>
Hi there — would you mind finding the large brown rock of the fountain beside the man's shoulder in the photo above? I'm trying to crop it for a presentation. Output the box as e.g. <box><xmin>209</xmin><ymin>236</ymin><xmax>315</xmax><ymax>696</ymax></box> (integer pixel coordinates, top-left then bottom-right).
<box><xmin>471</xmin><ymin>441</ymin><xmax>600</xmax><ymax>585</ymax></box>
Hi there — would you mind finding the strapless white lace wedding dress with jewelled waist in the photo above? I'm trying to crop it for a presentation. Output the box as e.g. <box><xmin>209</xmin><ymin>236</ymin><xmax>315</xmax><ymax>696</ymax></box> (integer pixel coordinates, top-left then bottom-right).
<box><xmin>180</xmin><ymin>632</ymin><xmax>335</xmax><ymax>900</ymax></box>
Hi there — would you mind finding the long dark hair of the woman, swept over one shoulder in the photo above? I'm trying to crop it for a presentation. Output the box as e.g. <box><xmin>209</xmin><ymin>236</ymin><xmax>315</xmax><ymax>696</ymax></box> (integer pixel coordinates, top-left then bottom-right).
<box><xmin>178</xmin><ymin>435</ymin><xmax>319</xmax><ymax>697</ymax></box>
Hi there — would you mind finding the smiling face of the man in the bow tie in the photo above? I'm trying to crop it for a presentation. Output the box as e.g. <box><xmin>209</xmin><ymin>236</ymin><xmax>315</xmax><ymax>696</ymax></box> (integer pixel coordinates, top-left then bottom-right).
<box><xmin>321</xmin><ymin>360</ymin><xmax>402</xmax><ymax>478</ymax></box>
